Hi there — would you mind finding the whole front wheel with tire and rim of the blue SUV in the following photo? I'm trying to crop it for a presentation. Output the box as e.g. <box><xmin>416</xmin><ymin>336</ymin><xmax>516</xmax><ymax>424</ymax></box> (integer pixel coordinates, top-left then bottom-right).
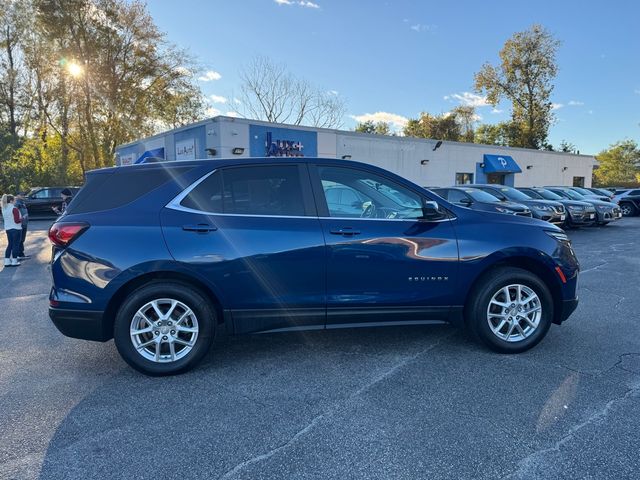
<box><xmin>465</xmin><ymin>267</ymin><xmax>553</xmax><ymax>353</ymax></box>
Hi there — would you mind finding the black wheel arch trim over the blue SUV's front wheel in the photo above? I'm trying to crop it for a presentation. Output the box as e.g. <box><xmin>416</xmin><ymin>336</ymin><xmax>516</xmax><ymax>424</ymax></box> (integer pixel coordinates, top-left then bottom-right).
<box><xmin>463</xmin><ymin>255</ymin><xmax>562</xmax><ymax>324</ymax></box>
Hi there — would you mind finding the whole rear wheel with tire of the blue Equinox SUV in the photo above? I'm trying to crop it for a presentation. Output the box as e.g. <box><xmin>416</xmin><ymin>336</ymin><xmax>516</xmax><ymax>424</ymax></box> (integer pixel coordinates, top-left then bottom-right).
<box><xmin>114</xmin><ymin>282</ymin><xmax>216</xmax><ymax>376</ymax></box>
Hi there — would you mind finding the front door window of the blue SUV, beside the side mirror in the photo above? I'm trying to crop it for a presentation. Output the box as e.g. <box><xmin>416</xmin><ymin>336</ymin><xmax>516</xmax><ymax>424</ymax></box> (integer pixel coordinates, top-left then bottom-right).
<box><xmin>318</xmin><ymin>167</ymin><xmax>423</xmax><ymax>219</ymax></box>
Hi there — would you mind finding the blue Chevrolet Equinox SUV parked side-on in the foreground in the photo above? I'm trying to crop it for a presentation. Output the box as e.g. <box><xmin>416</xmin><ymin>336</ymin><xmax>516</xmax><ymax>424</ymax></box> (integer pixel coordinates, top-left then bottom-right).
<box><xmin>49</xmin><ymin>158</ymin><xmax>579</xmax><ymax>375</ymax></box>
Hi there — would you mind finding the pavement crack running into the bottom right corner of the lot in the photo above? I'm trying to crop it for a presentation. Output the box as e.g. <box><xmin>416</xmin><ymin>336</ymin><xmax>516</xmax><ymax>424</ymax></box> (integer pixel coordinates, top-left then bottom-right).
<box><xmin>502</xmin><ymin>384</ymin><xmax>640</xmax><ymax>480</ymax></box>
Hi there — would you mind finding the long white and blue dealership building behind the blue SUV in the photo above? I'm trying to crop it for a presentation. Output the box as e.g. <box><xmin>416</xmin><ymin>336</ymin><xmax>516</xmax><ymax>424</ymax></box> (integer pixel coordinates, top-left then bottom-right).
<box><xmin>116</xmin><ymin>116</ymin><xmax>597</xmax><ymax>187</ymax></box>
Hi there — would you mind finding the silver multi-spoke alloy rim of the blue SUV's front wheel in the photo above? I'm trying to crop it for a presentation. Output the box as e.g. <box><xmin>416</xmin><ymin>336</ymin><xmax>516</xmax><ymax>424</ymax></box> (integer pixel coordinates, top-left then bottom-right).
<box><xmin>487</xmin><ymin>284</ymin><xmax>542</xmax><ymax>342</ymax></box>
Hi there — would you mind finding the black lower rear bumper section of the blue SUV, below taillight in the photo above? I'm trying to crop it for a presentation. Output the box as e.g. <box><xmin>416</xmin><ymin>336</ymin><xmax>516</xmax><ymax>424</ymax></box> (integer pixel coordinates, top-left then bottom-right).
<box><xmin>49</xmin><ymin>307</ymin><xmax>113</xmax><ymax>342</ymax></box>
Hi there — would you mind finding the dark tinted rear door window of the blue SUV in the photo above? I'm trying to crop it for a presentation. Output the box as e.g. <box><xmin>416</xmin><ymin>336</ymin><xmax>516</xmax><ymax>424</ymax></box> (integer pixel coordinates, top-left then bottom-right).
<box><xmin>181</xmin><ymin>165</ymin><xmax>305</xmax><ymax>216</ymax></box>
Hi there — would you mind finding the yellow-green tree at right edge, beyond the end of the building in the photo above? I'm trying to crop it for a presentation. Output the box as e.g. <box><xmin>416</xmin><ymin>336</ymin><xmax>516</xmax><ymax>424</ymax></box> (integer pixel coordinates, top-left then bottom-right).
<box><xmin>593</xmin><ymin>140</ymin><xmax>640</xmax><ymax>186</ymax></box>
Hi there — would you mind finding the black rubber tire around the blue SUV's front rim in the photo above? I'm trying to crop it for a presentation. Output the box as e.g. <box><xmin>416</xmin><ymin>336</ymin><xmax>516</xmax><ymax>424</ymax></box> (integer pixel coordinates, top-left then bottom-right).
<box><xmin>465</xmin><ymin>267</ymin><xmax>553</xmax><ymax>353</ymax></box>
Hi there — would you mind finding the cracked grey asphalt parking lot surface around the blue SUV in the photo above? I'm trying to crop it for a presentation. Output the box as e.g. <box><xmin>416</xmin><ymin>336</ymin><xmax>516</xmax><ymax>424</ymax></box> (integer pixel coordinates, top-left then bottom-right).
<box><xmin>0</xmin><ymin>217</ymin><xmax>640</xmax><ymax>479</ymax></box>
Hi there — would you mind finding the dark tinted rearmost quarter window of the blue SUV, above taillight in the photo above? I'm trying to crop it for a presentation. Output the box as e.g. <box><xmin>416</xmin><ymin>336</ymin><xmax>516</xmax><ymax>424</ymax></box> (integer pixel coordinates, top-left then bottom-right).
<box><xmin>67</xmin><ymin>167</ymin><xmax>193</xmax><ymax>214</ymax></box>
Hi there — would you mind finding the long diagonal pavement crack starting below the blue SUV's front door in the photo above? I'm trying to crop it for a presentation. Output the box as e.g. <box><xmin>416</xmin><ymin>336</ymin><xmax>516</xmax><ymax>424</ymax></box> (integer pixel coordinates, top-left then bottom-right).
<box><xmin>219</xmin><ymin>332</ymin><xmax>455</xmax><ymax>479</ymax></box>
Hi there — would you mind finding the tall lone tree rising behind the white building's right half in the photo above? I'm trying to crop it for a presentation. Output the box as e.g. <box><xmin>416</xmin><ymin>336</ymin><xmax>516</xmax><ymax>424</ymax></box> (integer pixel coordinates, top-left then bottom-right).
<box><xmin>475</xmin><ymin>25</ymin><xmax>560</xmax><ymax>149</ymax></box>
